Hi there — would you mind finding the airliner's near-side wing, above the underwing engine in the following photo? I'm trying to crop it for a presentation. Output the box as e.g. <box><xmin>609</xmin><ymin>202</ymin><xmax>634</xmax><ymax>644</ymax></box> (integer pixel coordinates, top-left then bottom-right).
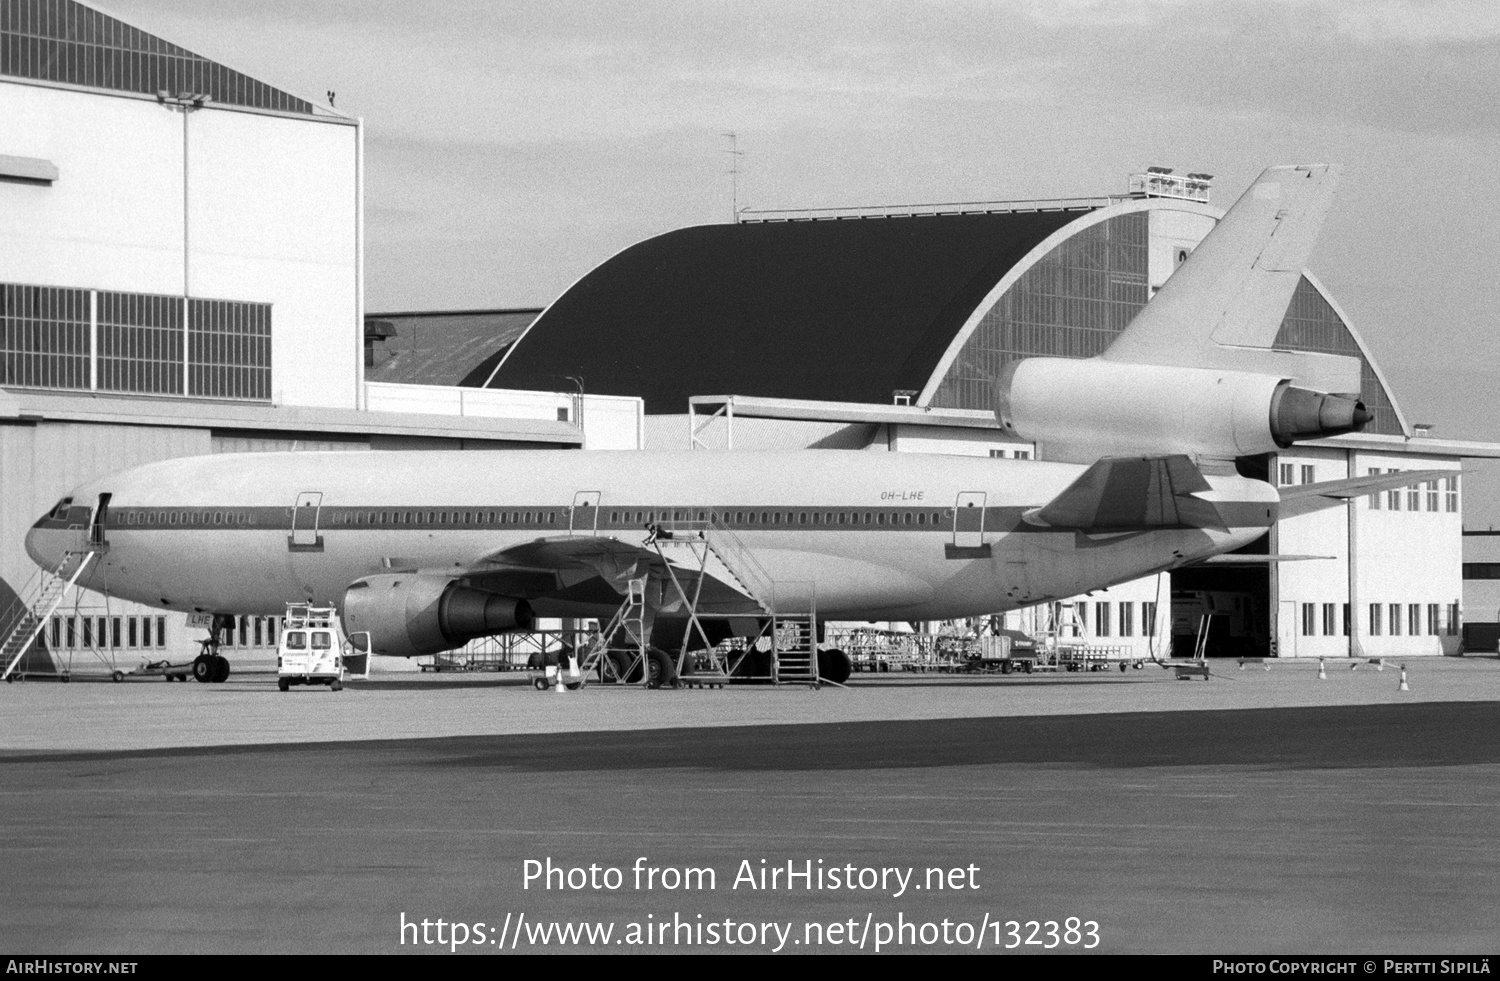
<box><xmin>465</xmin><ymin>536</ymin><xmax>764</xmax><ymax>614</ymax></box>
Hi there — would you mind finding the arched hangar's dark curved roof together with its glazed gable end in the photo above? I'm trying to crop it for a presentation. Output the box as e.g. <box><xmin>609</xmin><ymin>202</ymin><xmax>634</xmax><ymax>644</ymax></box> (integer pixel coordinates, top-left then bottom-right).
<box><xmin>489</xmin><ymin>198</ymin><xmax>1409</xmax><ymax>435</ymax></box>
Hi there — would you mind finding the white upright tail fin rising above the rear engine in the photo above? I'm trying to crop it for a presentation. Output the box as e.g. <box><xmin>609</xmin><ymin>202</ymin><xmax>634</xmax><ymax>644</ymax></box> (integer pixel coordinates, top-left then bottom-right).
<box><xmin>1100</xmin><ymin>164</ymin><xmax>1359</xmax><ymax>393</ymax></box>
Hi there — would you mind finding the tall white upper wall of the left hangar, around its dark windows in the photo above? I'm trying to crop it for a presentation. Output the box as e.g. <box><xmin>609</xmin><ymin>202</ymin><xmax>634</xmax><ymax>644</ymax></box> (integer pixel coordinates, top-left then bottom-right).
<box><xmin>0</xmin><ymin>77</ymin><xmax>363</xmax><ymax>408</ymax></box>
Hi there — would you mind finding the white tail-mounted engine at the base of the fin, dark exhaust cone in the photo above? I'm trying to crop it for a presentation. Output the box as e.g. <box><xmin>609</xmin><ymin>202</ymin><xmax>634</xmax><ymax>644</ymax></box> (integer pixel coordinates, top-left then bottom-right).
<box><xmin>995</xmin><ymin>357</ymin><xmax>1371</xmax><ymax>464</ymax></box>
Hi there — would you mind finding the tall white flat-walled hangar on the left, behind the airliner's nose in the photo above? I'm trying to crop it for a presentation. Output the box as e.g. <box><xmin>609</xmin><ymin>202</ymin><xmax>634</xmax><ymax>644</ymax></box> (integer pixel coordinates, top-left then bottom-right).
<box><xmin>0</xmin><ymin>0</ymin><xmax>641</xmax><ymax>669</ymax></box>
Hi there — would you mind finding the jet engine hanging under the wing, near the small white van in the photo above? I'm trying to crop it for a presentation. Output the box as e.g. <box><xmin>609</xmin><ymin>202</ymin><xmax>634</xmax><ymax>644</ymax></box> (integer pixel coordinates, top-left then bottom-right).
<box><xmin>344</xmin><ymin>573</ymin><xmax>536</xmax><ymax>657</ymax></box>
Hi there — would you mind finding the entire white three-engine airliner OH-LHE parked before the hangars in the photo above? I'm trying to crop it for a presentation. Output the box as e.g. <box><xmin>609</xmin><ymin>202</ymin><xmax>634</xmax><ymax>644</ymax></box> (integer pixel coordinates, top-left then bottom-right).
<box><xmin>14</xmin><ymin>165</ymin><xmax>1437</xmax><ymax>680</ymax></box>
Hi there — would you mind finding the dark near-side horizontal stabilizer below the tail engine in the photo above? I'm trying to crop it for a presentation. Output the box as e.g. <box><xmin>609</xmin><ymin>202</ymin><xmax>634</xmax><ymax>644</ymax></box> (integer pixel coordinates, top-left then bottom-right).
<box><xmin>1022</xmin><ymin>455</ymin><xmax>1224</xmax><ymax>533</ymax></box>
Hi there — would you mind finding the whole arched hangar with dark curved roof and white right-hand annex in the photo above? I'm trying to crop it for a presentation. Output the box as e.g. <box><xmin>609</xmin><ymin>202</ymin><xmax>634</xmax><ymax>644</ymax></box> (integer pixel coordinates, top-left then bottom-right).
<box><xmin>474</xmin><ymin>182</ymin><xmax>1497</xmax><ymax>657</ymax></box>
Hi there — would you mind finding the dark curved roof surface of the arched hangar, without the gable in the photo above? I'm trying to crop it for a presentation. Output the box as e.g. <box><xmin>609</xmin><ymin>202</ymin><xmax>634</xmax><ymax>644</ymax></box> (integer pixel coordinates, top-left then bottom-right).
<box><xmin>489</xmin><ymin>212</ymin><xmax>1082</xmax><ymax>413</ymax></box>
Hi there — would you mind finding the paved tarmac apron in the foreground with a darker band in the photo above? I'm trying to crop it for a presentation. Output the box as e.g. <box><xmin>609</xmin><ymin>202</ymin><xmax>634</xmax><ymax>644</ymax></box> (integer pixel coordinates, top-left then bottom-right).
<box><xmin>0</xmin><ymin>659</ymin><xmax>1500</xmax><ymax>956</ymax></box>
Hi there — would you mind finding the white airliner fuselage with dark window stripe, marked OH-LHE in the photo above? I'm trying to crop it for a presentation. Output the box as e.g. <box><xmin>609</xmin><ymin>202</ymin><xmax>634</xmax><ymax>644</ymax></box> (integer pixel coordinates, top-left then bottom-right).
<box><xmin>27</xmin><ymin>450</ymin><xmax>1277</xmax><ymax>620</ymax></box>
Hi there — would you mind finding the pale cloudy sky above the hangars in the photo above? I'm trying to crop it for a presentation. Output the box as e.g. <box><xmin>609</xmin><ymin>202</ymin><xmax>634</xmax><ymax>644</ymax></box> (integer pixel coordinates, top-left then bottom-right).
<box><xmin>99</xmin><ymin>0</ymin><xmax>1500</xmax><ymax>507</ymax></box>
